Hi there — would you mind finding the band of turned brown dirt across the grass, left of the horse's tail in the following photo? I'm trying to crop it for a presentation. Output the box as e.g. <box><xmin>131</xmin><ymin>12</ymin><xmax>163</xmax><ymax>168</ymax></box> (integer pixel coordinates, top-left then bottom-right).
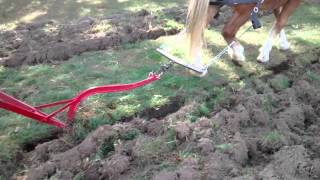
<box><xmin>0</xmin><ymin>10</ymin><xmax>184</xmax><ymax>67</ymax></box>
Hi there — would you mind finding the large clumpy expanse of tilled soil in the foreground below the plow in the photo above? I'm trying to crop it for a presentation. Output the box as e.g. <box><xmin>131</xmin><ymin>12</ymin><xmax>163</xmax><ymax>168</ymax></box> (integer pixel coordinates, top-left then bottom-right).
<box><xmin>12</xmin><ymin>49</ymin><xmax>320</xmax><ymax>180</ymax></box>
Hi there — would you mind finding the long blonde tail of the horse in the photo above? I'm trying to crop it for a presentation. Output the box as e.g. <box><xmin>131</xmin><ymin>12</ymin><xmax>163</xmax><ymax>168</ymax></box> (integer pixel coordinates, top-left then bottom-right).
<box><xmin>186</xmin><ymin>0</ymin><xmax>209</xmax><ymax>59</ymax></box>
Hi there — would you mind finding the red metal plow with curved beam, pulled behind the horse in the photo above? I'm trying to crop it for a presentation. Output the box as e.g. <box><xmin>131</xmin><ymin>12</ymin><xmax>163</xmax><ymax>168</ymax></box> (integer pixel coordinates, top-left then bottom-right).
<box><xmin>0</xmin><ymin>73</ymin><xmax>161</xmax><ymax>128</ymax></box>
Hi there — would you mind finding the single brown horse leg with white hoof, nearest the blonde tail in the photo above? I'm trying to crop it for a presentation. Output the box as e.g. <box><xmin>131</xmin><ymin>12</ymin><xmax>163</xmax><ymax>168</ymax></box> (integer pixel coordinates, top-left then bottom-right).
<box><xmin>222</xmin><ymin>5</ymin><xmax>253</xmax><ymax>61</ymax></box>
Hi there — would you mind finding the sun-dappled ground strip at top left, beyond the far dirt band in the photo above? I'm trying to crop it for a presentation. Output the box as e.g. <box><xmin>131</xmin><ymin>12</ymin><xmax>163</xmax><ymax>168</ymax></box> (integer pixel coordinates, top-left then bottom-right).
<box><xmin>0</xmin><ymin>0</ymin><xmax>186</xmax><ymax>30</ymax></box>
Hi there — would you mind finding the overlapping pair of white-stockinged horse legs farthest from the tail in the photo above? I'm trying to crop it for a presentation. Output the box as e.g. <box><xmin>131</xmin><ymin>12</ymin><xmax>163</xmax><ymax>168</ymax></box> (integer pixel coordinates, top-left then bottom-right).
<box><xmin>257</xmin><ymin>0</ymin><xmax>301</xmax><ymax>62</ymax></box>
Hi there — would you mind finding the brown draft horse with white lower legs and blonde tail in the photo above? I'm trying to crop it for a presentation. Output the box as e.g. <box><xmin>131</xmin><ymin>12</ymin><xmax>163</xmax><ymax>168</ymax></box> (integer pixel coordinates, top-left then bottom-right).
<box><xmin>186</xmin><ymin>0</ymin><xmax>301</xmax><ymax>64</ymax></box>
